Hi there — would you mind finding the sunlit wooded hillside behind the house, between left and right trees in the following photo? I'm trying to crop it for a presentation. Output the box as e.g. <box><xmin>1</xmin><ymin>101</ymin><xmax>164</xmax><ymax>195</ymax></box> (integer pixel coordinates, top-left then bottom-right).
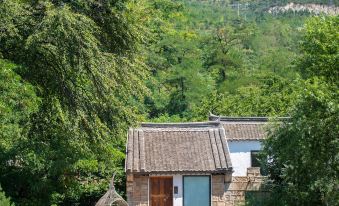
<box><xmin>145</xmin><ymin>1</ymin><xmax>306</xmax><ymax>121</ymax></box>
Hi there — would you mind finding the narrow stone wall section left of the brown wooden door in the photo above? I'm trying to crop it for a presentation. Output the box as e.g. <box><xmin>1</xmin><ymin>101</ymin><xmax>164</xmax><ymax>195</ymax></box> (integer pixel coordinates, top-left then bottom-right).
<box><xmin>126</xmin><ymin>175</ymin><xmax>149</xmax><ymax>206</ymax></box>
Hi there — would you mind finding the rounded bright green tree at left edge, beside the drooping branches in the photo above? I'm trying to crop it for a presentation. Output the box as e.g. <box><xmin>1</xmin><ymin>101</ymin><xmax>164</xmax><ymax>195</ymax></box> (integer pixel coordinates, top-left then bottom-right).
<box><xmin>0</xmin><ymin>59</ymin><xmax>40</xmax><ymax>157</ymax></box>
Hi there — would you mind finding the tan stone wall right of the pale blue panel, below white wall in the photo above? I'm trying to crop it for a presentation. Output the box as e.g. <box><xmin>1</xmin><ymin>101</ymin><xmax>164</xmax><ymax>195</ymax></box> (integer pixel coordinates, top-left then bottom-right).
<box><xmin>212</xmin><ymin>168</ymin><xmax>265</xmax><ymax>206</ymax></box>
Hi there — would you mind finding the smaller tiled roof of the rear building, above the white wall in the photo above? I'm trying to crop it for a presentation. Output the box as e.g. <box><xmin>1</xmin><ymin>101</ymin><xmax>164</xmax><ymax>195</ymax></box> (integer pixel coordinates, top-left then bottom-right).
<box><xmin>209</xmin><ymin>115</ymin><xmax>288</xmax><ymax>141</ymax></box>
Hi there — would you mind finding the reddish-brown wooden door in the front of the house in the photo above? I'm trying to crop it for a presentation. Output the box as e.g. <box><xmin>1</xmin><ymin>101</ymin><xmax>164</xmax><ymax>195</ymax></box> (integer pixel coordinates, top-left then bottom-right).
<box><xmin>150</xmin><ymin>177</ymin><xmax>173</xmax><ymax>206</ymax></box>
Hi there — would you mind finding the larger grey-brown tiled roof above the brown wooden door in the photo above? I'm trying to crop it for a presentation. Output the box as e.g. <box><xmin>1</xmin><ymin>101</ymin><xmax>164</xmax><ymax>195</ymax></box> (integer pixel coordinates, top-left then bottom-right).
<box><xmin>126</xmin><ymin>122</ymin><xmax>232</xmax><ymax>173</ymax></box>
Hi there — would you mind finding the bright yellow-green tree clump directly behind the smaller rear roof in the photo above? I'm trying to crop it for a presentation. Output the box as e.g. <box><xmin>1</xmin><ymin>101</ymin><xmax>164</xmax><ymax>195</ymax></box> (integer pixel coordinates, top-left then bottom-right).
<box><xmin>194</xmin><ymin>73</ymin><xmax>300</xmax><ymax>120</ymax></box>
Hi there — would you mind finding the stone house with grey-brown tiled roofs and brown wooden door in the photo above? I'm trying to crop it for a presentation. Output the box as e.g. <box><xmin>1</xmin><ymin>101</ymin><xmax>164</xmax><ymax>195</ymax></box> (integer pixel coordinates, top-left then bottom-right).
<box><xmin>125</xmin><ymin>115</ymin><xmax>274</xmax><ymax>206</ymax></box>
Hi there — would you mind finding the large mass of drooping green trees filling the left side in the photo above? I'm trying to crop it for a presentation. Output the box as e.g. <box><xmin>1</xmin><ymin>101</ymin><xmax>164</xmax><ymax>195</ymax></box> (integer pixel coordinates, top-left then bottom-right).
<box><xmin>0</xmin><ymin>0</ymin><xmax>147</xmax><ymax>205</ymax></box>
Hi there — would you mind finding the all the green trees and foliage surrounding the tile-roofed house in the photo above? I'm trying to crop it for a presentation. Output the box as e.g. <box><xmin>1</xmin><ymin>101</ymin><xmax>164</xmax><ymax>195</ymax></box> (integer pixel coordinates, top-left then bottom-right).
<box><xmin>0</xmin><ymin>0</ymin><xmax>339</xmax><ymax>205</ymax></box>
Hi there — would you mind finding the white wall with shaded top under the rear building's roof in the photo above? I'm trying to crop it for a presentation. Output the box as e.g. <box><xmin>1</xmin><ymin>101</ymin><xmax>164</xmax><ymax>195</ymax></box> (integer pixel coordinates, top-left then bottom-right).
<box><xmin>227</xmin><ymin>140</ymin><xmax>262</xmax><ymax>176</ymax></box>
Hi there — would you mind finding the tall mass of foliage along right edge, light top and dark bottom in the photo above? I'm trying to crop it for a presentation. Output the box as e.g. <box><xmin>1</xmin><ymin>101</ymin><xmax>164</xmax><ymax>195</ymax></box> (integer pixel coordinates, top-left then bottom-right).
<box><xmin>258</xmin><ymin>17</ymin><xmax>339</xmax><ymax>205</ymax></box>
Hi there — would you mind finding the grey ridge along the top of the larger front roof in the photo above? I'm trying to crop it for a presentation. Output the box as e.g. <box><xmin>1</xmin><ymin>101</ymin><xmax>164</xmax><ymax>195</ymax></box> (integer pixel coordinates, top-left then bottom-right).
<box><xmin>141</xmin><ymin>121</ymin><xmax>220</xmax><ymax>128</ymax></box>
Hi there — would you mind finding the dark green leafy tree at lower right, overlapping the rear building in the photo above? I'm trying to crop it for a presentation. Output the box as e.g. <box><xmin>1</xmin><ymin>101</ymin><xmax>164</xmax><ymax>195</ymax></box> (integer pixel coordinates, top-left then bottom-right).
<box><xmin>264</xmin><ymin>79</ymin><xmax>339</xmax><ymax>205</ymax></box>
